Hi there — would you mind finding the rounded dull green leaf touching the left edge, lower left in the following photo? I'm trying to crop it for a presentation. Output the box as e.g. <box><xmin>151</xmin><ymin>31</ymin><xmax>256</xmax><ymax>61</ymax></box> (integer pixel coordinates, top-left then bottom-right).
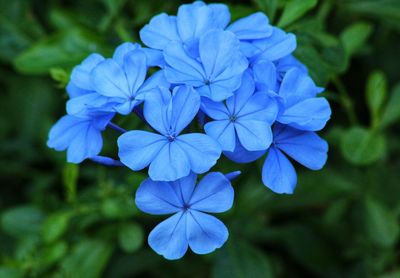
<box><xmin>1</xmin><ymin>206</ymin><xmax>43</xmax><ymax>237</ymax></box>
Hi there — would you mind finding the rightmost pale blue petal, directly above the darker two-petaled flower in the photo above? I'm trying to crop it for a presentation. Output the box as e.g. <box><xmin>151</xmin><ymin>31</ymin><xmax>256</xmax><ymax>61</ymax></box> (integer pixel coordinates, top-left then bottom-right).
<box><xmin>277</xmin><ymin>97</ymin><xmax>331</xmax><ymax>131</ymax></box>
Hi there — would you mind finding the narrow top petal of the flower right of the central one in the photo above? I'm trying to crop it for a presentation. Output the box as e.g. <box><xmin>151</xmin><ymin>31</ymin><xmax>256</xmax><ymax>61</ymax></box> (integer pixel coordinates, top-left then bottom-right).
<box><xmin>226</xmin><ymin>71</ymin><xmax>255</xmax><ymax>115</ymax></box>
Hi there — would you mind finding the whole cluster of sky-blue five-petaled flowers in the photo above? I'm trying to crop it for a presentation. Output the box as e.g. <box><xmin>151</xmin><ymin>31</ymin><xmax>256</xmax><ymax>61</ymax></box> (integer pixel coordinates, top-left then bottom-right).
<box><xmin>48</xmin><ymin>1</ymin><xmax>331</xmax><ymax>259</ymax></box>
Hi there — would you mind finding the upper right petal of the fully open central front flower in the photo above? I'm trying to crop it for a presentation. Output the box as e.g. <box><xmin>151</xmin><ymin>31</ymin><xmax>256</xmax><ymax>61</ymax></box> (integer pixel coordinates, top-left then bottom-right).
<box><xmin>169</xmin><ymin>86</ymin><xmax>200</xmax><ymax>136</ymax></box>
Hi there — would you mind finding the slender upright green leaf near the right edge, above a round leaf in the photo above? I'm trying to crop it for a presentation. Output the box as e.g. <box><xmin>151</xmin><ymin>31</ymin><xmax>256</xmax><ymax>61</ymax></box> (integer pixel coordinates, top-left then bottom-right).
<box><xmin>366</xmin><ymin>71</ymin><xmax>387</xmax><ymax>127</ymax></box>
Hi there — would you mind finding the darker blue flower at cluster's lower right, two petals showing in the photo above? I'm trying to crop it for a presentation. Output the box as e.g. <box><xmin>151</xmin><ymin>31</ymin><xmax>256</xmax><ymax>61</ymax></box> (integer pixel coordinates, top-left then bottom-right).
<box><xmin>262</xmin><ymin>124</ymin><xmax>328</xmax><ymax>194</ymax></box>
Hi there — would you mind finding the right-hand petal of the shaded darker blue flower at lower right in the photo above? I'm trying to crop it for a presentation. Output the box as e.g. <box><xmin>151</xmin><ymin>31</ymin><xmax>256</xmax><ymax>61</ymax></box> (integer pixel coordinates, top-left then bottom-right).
<box><xmin>274</xmin><ymin>125</ymin><xmax>328</xmax><ymax>170</ymax></box>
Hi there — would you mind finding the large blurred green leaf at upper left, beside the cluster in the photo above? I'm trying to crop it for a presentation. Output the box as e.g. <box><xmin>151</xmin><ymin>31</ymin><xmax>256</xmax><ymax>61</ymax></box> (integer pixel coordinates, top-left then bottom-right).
<box><xmin>14</xmin><ymin>29</ymin><xmax>106</xmax><ymax>74</ymax></box>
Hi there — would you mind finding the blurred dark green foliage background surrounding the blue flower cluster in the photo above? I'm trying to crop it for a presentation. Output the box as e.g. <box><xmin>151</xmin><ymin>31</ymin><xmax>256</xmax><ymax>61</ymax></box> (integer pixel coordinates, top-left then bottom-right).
<box><xmin>0</xmin><ymin>0</ymin><xmax>400</xmax><ymax>278</ymax></box>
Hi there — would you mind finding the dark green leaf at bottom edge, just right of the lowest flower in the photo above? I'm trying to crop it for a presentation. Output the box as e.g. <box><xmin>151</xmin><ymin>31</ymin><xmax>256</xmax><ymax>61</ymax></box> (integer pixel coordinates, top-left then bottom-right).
<box><xmin>212</xmin><ymin>238</ymin><xmax>274</xmax><ymax>278</ymax></box>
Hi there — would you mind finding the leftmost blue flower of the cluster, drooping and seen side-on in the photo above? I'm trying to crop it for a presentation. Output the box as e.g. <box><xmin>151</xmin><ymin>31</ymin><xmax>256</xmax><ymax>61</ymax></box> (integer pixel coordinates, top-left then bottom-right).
<box><xmin>47</xmin><ymin>113</ymin><xmax>114</xmax><ymax>163</ymax></box>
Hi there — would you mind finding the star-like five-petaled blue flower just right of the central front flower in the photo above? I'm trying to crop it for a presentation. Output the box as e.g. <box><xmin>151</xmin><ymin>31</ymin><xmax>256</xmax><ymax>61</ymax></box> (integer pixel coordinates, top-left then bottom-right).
<box><xmin>202</xmin><ymin>70</ymin><xmax>278</xmax><ymax>152</ymax></box>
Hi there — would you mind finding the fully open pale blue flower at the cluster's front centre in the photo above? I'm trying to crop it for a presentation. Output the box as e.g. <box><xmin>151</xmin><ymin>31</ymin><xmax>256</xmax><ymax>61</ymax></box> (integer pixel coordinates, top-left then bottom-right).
<box><xmin>118</xmin><ymin>86</ymin><xmax>221</xmax><ymax>181</ymax></box>
